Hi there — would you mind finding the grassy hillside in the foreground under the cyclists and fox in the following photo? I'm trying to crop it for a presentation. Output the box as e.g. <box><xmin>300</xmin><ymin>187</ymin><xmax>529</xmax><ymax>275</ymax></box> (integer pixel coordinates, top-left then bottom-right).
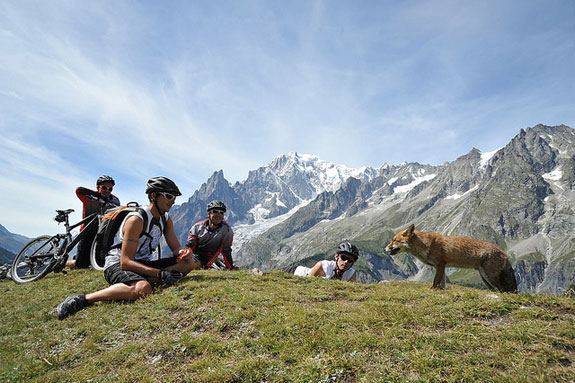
<box><xmin>0</xmin><ymin>271</ymin><xmax>575</xmax><ymax>383</ymax></box>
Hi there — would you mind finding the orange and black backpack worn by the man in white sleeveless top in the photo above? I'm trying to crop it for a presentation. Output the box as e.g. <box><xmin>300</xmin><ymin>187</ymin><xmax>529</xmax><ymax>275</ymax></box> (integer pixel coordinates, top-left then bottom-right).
<box><xmin>92</xmin><ymin>202</ymin><xmax>154</xmax><ymax>270</ymax></box>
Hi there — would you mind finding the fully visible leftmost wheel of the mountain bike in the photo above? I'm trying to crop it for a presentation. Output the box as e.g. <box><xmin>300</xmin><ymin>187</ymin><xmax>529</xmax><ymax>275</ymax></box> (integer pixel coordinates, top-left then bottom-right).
<box><xmin>11</xmin><ymin>235</ymin><xmax>58</xmax><ymax>283</ymax></box>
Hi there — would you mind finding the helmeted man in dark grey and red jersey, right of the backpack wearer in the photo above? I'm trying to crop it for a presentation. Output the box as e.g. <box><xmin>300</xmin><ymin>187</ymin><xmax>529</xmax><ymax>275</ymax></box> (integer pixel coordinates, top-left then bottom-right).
<box><xmin>182</xmin><ymin>201</ymin><xmax>237</xmax><ymax>270</ymax></box>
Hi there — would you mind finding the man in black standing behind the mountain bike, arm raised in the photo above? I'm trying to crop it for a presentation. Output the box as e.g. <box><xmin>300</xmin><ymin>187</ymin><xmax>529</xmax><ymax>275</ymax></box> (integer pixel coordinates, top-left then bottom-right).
<box><xmin>66</xmin><ymin>175</ymin><xmax>120</xmax><ymax>269</ymax></box>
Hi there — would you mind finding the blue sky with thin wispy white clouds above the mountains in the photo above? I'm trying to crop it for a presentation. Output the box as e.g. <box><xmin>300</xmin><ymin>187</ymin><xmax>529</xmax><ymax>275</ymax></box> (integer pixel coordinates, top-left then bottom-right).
<box><xmin>0</xmin><ymin>0</ymin><xmax>575</xmax><ymax>236</ymax></box>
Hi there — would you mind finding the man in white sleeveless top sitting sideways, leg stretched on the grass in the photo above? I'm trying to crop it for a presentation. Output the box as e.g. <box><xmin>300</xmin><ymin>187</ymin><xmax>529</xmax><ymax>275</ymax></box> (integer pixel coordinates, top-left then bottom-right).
<box><xmin>56</xmin><ymin>177</ymin><xmax>199</xmax><ymax>319</ymax></box>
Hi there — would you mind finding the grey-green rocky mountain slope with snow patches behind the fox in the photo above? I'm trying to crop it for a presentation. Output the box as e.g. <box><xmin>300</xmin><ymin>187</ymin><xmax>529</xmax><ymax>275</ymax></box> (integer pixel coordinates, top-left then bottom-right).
<box><xmin>237</xmin><ymin>125</ymin><xmax>575</xmax><ymax>294</ymax></box>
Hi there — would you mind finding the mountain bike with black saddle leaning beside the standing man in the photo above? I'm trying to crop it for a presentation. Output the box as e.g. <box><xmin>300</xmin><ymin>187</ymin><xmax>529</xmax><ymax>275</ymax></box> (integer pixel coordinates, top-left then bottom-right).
<box><xmin>11</xmin><ymin>209</ymin><xmax>99</xmax><ymax>283</ymax></box>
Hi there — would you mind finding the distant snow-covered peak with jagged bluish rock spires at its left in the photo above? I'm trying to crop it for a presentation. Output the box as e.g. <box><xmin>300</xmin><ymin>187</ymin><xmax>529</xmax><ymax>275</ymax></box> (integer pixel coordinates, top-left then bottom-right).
<box><xmin>171</xmin><ymin>152</ymin><xmax>377</xmax><ymax>250</ymax></box>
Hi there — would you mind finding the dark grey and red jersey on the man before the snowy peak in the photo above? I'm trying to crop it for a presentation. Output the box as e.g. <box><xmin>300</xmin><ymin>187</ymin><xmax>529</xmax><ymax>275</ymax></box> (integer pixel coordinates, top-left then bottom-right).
<box><xmin>186</xmin><ymin>219</ymin><xmax>234</xmax><ymax>269</ymax></box>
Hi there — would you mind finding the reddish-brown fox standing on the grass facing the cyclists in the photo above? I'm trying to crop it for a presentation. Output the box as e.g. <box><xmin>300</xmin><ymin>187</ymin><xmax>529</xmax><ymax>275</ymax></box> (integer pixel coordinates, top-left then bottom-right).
<box><xmin>385</xmin><ymin>225</ymin><xmax>517</xmax><ymax>293</ymax></box>
